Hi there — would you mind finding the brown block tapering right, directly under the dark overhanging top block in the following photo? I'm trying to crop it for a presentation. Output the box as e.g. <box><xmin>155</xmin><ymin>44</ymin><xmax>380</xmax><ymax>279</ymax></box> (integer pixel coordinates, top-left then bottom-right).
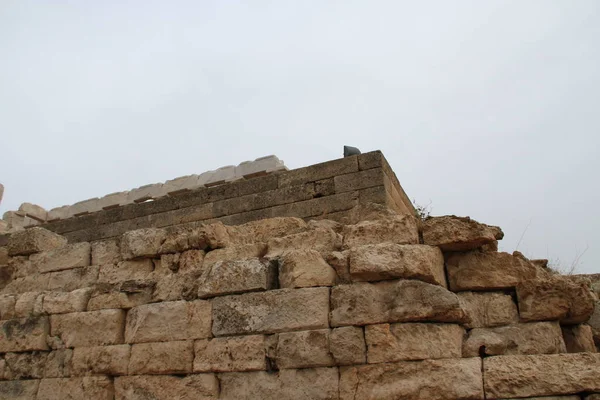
<box><xmin>446</xmin><ymin>251</ymin><xmax>545</xmax><ymax>291</ymax></box>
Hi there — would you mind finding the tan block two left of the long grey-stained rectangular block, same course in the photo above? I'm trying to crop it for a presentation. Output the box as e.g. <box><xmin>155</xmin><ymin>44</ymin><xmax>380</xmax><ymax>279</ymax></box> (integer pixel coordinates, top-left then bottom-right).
<box><xmin>50</xmin><ymin>310</ymin><xmax>125</xmax><ymax>347</ymax></box>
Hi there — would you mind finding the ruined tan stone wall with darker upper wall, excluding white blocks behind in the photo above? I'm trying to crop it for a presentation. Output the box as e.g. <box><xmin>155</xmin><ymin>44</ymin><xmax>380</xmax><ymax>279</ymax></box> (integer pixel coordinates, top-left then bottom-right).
<box><xmin>0</xmin><ymin>152</ymin><xmax>600</xmax><ymax>400</ymax></box>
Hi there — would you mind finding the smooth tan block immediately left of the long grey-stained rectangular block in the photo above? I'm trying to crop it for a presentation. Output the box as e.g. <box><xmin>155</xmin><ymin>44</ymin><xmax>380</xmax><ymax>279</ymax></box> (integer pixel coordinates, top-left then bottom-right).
<box><xmin>125</xmin><ymin>300</ymin><xmax>211</xmax><ymax>343</ymax></box>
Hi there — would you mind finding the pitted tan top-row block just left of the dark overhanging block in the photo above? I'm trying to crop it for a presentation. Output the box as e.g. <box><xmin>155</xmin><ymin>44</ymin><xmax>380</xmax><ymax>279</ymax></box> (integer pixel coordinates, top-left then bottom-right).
<box><xmin>343</xmin><ymin>215</ymin><xmax>419</xmax><ymax>249</ymax></box>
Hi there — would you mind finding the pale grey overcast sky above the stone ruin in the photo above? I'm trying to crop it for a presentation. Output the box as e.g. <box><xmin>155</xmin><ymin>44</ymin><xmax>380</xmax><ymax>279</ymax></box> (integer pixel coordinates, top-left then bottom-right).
<box><xmin>0</xmin><ymin>0</ymin><xmax>600</xmax><ymax>273</ymax></box>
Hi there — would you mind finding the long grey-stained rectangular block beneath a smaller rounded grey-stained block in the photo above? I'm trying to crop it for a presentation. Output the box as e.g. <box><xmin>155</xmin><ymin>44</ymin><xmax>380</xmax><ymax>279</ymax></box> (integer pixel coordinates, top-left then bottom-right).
<box><xmin>212</xmin><ymin>288</ymin><xmax>329</xmax><ymax>336</ymax></box>
